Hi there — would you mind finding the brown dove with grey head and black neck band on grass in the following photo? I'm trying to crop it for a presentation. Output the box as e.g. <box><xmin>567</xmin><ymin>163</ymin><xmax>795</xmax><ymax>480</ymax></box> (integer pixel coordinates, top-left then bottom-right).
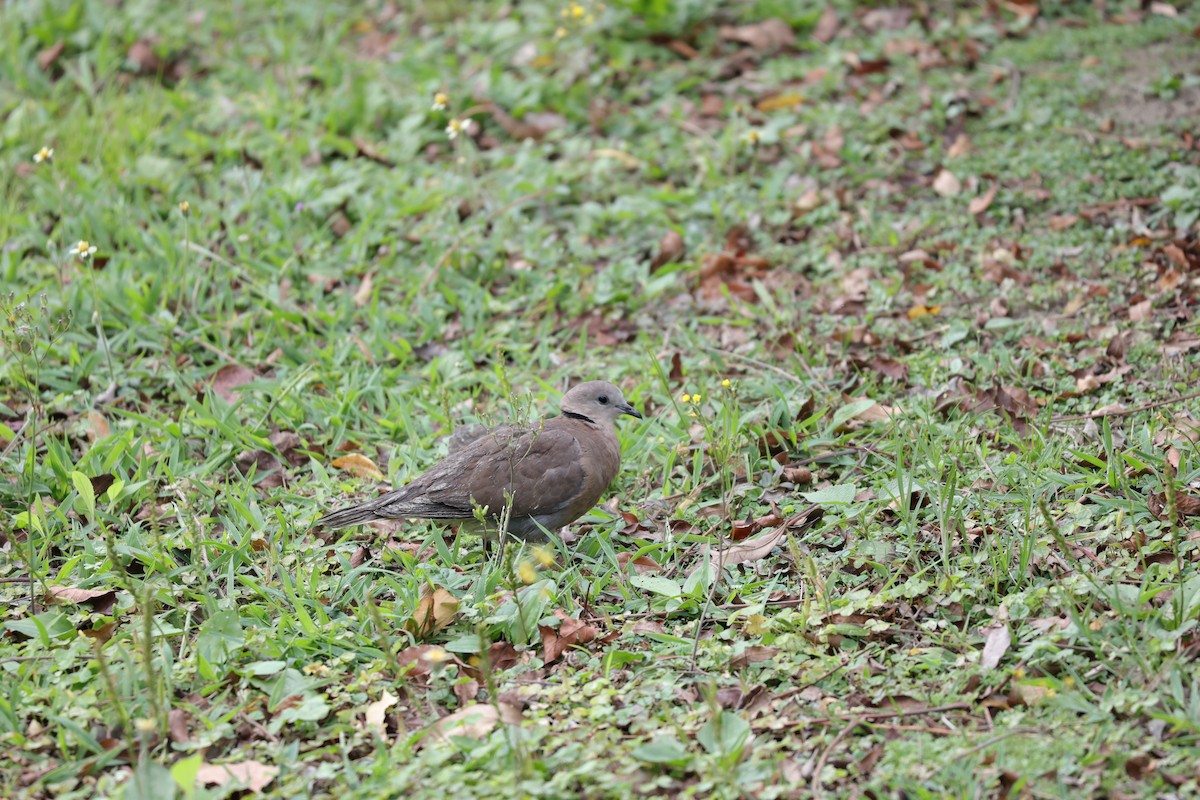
<box><xmin>314</xmin><ymin>380</ymin><xmax>643</xmax><ymax>542</ymax></box>
